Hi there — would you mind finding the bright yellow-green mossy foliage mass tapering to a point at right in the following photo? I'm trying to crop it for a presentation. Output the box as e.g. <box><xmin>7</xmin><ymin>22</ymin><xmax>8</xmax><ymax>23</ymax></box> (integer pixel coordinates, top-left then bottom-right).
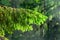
<box><xmin>0</xmin><ymin>7</ymin><xmax>47</xmax><ymax>35</ymax></box>
